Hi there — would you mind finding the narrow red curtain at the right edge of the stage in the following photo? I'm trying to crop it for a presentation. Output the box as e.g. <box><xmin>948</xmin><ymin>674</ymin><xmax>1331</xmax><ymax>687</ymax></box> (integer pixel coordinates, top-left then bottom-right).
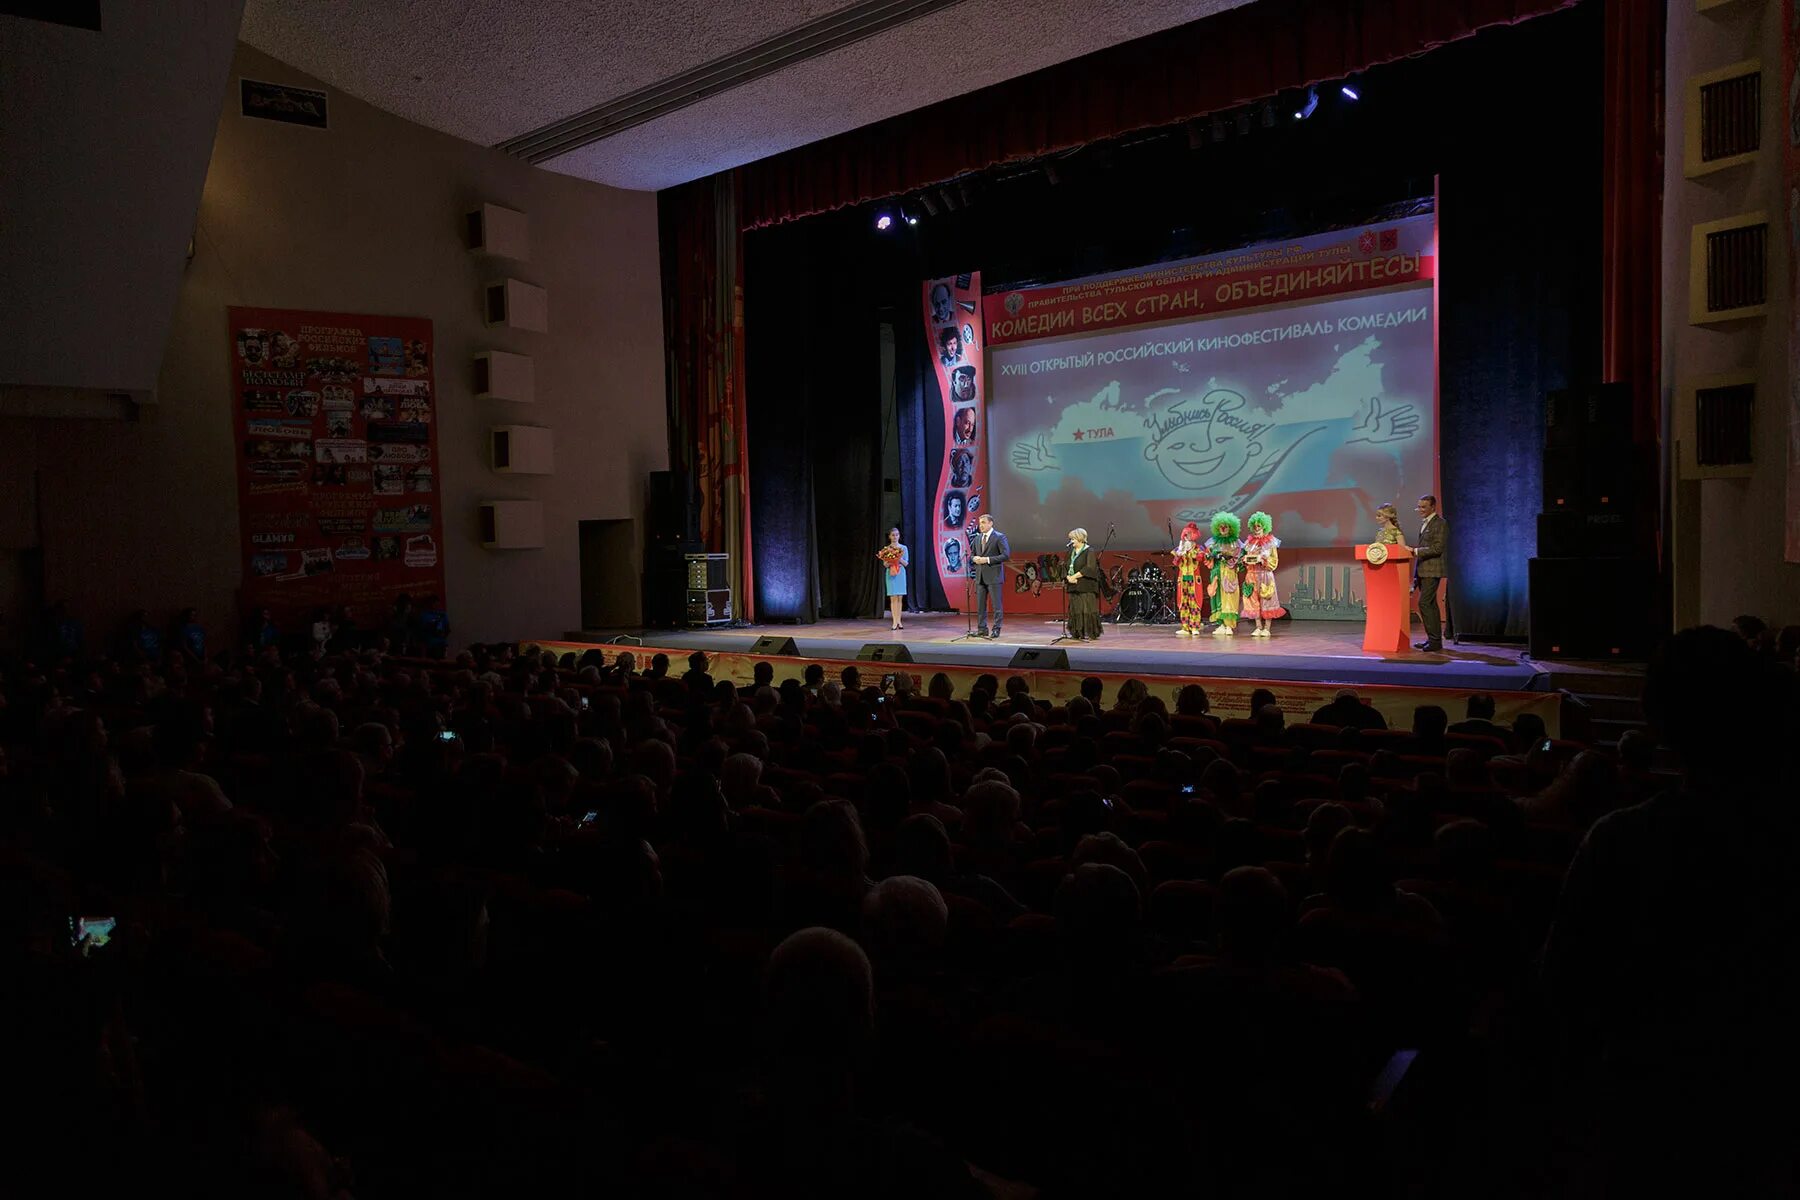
<box><xmin>1600</xmin><ymin>0</ymin><xmax>1667</xmax><ymax>449</ymax></box>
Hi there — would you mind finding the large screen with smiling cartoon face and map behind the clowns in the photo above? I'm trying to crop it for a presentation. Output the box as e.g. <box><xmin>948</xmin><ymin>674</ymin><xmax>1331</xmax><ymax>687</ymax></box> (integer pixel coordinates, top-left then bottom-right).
<box><xmin>986</xmin><ymin>214</ymin><xmax>1438</xmax><ymax>551</ymax></box>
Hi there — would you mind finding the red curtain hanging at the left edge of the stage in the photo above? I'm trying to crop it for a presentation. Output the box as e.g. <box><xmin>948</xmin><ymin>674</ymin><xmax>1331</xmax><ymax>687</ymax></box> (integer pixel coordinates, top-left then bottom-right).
<box><xmin>657</xmin><ymin>173</ymin><xmax>756</xmax><ymax>621</ymax></box>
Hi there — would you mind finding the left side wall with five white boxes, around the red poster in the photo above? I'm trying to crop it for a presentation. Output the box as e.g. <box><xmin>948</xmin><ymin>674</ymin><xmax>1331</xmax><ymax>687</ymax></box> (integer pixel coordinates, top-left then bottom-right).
<box><xmin>0</xmin><ymin>45</ymin><xmax>668</xmax><ymax>644</ymax></box>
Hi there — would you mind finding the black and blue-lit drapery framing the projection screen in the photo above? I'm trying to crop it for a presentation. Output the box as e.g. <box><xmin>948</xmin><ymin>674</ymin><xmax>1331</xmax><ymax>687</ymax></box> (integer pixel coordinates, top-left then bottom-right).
<box><xmin>745</xmin><ymin>2</ymin><xmax>1602</xmax><ymax>637</ymax></box>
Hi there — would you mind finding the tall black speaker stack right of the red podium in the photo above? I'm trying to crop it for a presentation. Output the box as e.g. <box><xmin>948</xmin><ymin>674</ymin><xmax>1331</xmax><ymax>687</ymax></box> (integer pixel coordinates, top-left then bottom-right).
<box><xmin>1530</xmin><ymin>383</ymin><xmax>1656</xmax><ymax>658</ymax></box>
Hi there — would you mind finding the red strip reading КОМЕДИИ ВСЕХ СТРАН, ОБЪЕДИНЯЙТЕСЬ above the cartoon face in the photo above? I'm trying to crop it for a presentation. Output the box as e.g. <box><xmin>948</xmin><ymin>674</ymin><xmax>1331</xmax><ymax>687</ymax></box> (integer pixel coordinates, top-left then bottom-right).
<box><xmin>983</xmin><ymin>221</ymin><xmax>1436</xmax><ymax>345</ymax></box>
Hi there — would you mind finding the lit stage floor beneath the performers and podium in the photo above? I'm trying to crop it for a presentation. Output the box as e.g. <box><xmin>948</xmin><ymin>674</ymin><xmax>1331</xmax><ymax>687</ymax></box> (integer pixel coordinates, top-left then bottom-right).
<box><xmin>567</xmin><ymin>613</ymin><xmax>1550</xmax><ymax>691</ymax></box>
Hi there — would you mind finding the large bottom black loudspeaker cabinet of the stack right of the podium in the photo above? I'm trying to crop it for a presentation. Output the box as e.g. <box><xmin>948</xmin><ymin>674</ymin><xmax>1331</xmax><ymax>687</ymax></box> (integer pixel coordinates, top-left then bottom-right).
<box><xmin>1530</xmin><ymin>556</ymin><xmax>1656</xmax><ymax>662</ymax></box>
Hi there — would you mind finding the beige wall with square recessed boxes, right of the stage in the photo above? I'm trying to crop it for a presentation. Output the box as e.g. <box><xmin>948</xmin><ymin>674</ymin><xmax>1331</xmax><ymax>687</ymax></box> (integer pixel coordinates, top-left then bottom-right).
<box><xmin>1663</xmin><ymin>0</ymin><xmax>1800</xmax><ymax>628</ymax></box>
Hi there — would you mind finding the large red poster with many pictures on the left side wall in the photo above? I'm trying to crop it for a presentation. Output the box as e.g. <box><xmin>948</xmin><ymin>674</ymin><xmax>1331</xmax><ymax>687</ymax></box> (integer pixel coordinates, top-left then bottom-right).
<box><xmin>229</xmin><ymin>308</ymin><xmax>445</xmax><ymax>630</ymax></box>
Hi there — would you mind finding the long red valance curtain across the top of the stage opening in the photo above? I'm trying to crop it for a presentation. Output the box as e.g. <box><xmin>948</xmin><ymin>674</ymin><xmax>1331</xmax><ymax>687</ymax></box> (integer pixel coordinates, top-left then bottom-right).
<box><xmin>738</xmin><ymin>0</ymin><xmax>1576</xmax><ymax>228</ymax></box>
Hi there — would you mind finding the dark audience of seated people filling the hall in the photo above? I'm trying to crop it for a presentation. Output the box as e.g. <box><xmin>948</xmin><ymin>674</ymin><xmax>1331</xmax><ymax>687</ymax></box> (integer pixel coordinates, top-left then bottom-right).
<box><xmin>0</xmin><ymin>630</ymin><xmax>1800</xmax><ymax>1196</ymax></box>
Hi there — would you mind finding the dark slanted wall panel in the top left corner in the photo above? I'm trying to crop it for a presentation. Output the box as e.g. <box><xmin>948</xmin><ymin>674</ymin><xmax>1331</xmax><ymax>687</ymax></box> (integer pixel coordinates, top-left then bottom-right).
<box><xmin>0</xmin><ymin>0</ymin><xmax>243</xmax><ymax>392</ymax></box>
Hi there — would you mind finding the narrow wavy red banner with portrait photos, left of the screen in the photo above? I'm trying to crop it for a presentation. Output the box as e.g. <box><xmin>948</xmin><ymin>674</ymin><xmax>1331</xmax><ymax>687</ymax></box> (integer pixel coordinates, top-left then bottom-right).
<box><xmin>913</xmin><ymin>272</ymin><xmax>988</xmax><ymax>608</ymax></box>
